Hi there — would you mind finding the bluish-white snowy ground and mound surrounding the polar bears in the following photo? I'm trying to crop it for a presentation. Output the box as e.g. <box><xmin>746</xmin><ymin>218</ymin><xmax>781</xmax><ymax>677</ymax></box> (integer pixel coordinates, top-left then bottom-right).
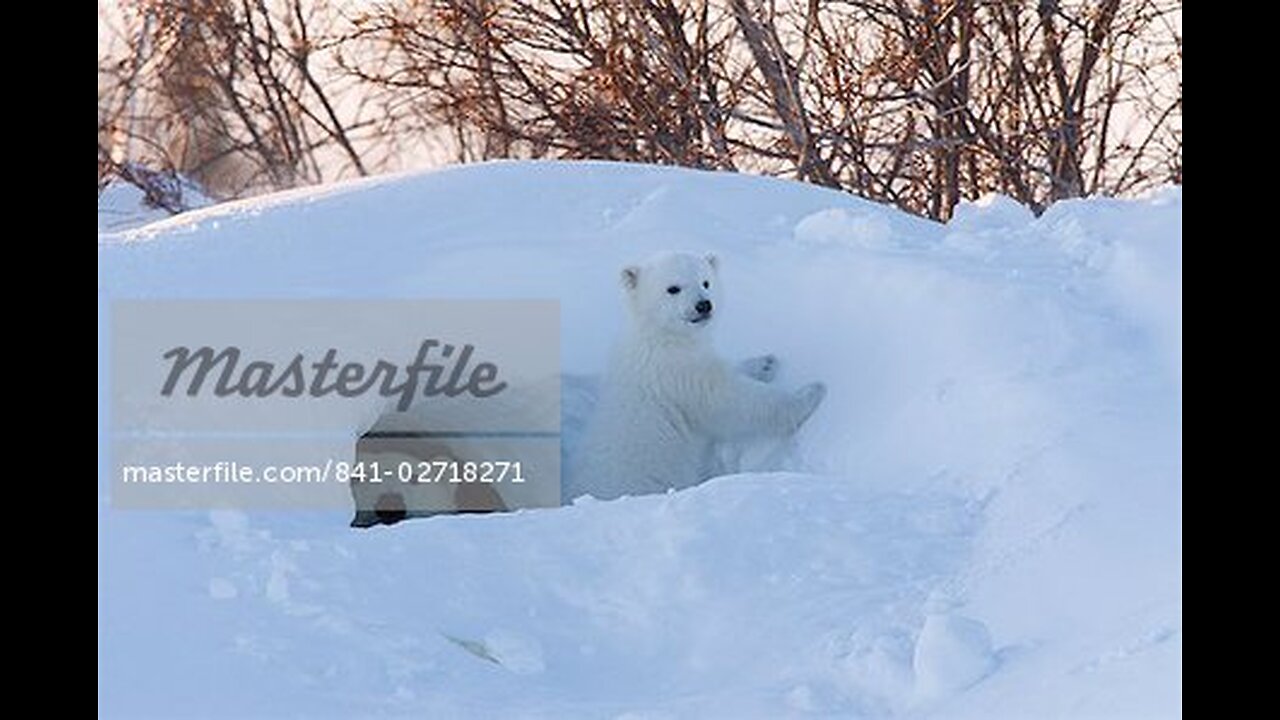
<box><xmin>97</xmin><ymin>163</ymin><xmax>1183</xmax><ymax>719</ymax></box>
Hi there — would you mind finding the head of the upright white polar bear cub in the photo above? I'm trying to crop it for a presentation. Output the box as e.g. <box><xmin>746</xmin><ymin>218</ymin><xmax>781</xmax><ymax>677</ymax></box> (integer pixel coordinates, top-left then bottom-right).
<box><xmin>621</xmin><ymin>252</ymin><xmax>719</xmax><ymax>336</ymax></box>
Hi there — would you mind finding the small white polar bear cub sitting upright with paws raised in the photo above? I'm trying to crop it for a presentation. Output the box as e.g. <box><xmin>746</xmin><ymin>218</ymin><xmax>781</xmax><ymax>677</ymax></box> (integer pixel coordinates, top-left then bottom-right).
<box><xmin>563</xmin><ymin>252</ymin><xmax>826</xmax><ymax>500</ymax></box>
